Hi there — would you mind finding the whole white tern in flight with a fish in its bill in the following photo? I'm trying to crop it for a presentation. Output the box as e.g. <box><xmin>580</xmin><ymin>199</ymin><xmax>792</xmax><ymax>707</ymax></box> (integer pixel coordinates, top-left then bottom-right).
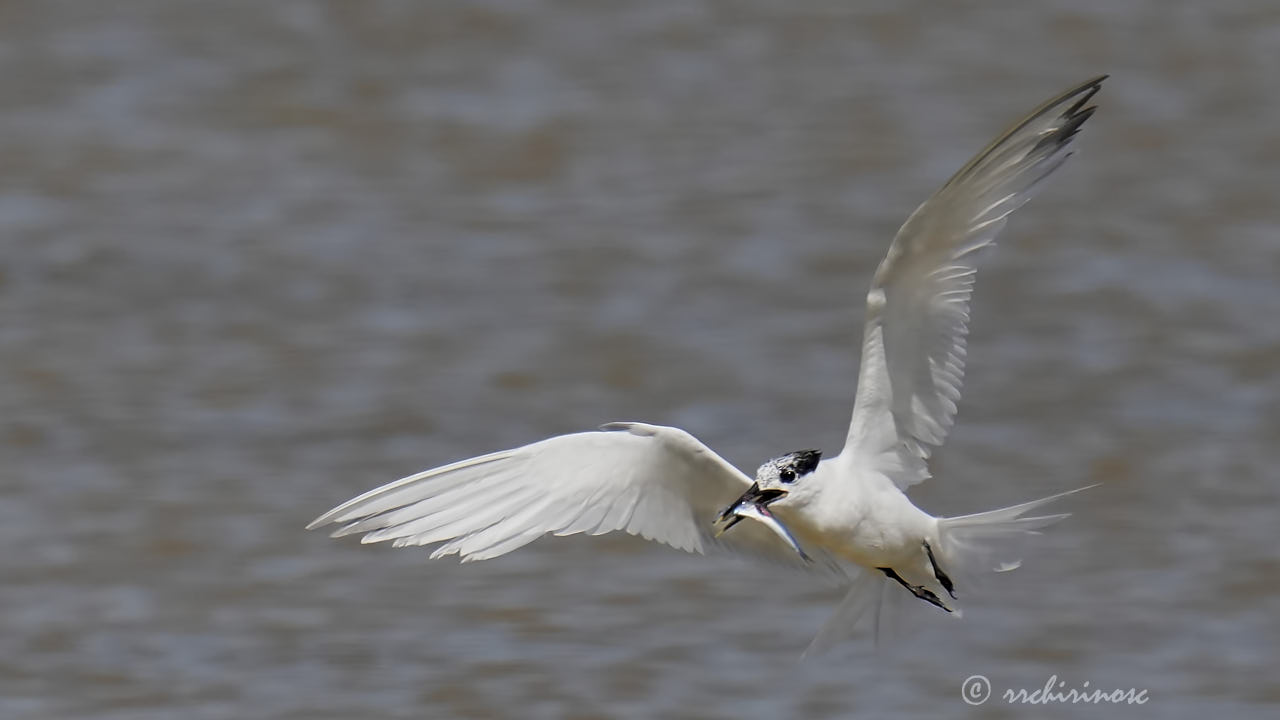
<box><xmin>307</xmin><ymin>76</ymin><xmax>1106</xmax><ymax>652</ymax></box>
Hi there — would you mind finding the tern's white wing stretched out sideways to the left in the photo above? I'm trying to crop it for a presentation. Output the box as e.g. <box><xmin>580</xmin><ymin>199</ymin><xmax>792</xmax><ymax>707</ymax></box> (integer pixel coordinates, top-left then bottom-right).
<box><xmin>307</xmin><ymin>423</ymin><xmax>838</xmax><ymax>574</ymax></box>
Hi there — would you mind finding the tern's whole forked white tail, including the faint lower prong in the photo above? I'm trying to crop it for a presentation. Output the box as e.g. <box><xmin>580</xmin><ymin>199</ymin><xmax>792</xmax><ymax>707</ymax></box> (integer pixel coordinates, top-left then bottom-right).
<box><xmin>805</xmin><ymin>486</ymin><xmax>1097</xmax><ymax>657</ymax></box>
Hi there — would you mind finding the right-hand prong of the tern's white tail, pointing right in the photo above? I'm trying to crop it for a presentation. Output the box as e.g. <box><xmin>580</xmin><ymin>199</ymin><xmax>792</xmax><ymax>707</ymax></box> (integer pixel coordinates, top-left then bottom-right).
<box><xmin>934</xmin><ymin>486</ymin><xmax>1097</xmax><ymax>588</ymax></box>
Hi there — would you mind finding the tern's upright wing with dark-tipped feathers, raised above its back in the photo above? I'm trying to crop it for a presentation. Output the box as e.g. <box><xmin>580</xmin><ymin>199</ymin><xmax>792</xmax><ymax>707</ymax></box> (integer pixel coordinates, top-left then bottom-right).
<box><xmin>842</xmin><ymin>76</ymin><xmax>1106</xmax><ymax>489</ymax></box>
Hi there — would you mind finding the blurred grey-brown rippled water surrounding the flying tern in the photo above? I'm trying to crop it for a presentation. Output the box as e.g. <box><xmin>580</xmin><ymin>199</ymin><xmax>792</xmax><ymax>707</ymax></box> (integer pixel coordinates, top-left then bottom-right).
<box><xmin>0</xmin><ymin>0</ymin><xmax>1280</xmax><ymax>720</ymax></box>
